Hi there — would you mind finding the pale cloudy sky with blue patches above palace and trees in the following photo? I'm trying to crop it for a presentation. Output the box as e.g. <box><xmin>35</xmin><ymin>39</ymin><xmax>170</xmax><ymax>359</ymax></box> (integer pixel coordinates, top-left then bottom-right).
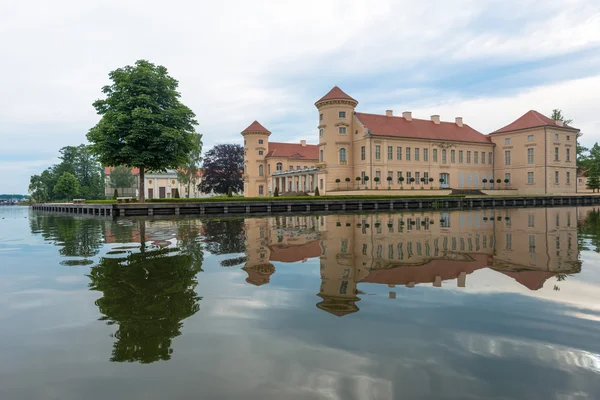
<box><xmin>0</xmin><ymin>0</ymin><xmax>600</xmax><ymax>193</ymax></box>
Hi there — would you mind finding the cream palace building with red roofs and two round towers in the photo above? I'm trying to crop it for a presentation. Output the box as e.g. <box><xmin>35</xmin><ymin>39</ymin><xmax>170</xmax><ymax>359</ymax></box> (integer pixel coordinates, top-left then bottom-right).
<box><xmin>242</xmin><ymin>86</ymin><xmax>579</xmax><ymax>197</ymax></box>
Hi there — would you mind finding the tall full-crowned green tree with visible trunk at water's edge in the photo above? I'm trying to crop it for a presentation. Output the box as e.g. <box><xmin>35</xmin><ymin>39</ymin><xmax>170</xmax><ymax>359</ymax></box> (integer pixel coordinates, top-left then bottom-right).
<box><xmin>87</xmin><ymin>60</ymin><xmax>198</xmax><ymax>201</ymax></box>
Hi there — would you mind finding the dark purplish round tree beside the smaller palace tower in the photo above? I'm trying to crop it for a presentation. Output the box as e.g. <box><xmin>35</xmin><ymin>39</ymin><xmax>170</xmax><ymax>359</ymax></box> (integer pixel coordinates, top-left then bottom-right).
<box><xmin>200</xmin><ymin>144</ymin><xmax>244</xmax><ymax>194</ymax></box>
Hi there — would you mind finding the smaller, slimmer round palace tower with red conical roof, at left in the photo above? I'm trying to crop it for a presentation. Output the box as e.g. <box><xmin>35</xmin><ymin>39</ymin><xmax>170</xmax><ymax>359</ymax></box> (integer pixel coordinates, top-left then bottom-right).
<box><xmin>242</xmin><ymin>121</ymin><xmax>271</xmax><ymax>197</ymax></box>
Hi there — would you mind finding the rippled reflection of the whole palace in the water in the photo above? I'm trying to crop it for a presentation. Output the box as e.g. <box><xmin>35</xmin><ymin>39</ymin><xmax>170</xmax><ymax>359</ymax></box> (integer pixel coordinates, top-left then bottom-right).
<box><xmin>243</xmin><ymin>207</ymin><xmax>582</xmax><ymax>316</ymax></box>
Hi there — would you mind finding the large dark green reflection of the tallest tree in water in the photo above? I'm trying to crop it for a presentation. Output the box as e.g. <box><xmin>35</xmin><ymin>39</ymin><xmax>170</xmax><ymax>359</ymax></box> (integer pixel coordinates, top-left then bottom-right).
<box><xmin>89</xmin><ymin>220</ymin><xmax>202</xmax><ymax>363</ymax></box>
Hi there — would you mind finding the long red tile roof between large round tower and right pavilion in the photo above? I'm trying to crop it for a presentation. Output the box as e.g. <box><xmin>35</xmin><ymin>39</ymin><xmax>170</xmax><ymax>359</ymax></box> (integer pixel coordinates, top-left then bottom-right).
<box><xmin>355</xmin><ymin>112</ymin><xmax>491</xmax><ymax>143</ymax></box>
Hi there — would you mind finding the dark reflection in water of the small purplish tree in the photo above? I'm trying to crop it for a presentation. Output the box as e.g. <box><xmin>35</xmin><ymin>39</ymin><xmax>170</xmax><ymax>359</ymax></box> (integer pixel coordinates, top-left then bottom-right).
<box><xmin>203</xmin><ymin>219</ymin><xmax>246</xmax><ymax>254</ymax></box>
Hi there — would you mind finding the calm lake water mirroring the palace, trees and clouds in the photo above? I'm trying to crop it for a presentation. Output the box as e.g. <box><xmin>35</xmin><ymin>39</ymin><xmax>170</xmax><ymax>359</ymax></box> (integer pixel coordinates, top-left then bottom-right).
<box><xmin>0</xmin><ymin>207</ymin><xmax>600</xmax><ymax>400</ymax></box>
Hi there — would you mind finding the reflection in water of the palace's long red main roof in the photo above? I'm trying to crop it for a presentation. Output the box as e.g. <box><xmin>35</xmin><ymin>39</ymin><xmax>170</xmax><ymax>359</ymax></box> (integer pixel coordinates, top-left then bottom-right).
<box><xmin>361</xmin><ymin>254</ymin><xmax>489</xmax><ymax>285</ymax></box>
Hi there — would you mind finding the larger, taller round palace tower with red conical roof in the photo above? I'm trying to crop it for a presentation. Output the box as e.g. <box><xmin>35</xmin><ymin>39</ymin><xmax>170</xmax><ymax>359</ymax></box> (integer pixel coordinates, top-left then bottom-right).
<box><xmin>315</xmin><ymin>86</ymin><xmax>358</xmax><ymax>193</ymax></box>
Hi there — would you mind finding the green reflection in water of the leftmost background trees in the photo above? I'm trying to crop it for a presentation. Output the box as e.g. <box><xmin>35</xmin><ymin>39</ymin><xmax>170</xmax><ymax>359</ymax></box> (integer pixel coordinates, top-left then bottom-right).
<box><xmin>29</xmin><ymin>213</ymin><xmax>105</xmax><ymax>257</ymax></box>
